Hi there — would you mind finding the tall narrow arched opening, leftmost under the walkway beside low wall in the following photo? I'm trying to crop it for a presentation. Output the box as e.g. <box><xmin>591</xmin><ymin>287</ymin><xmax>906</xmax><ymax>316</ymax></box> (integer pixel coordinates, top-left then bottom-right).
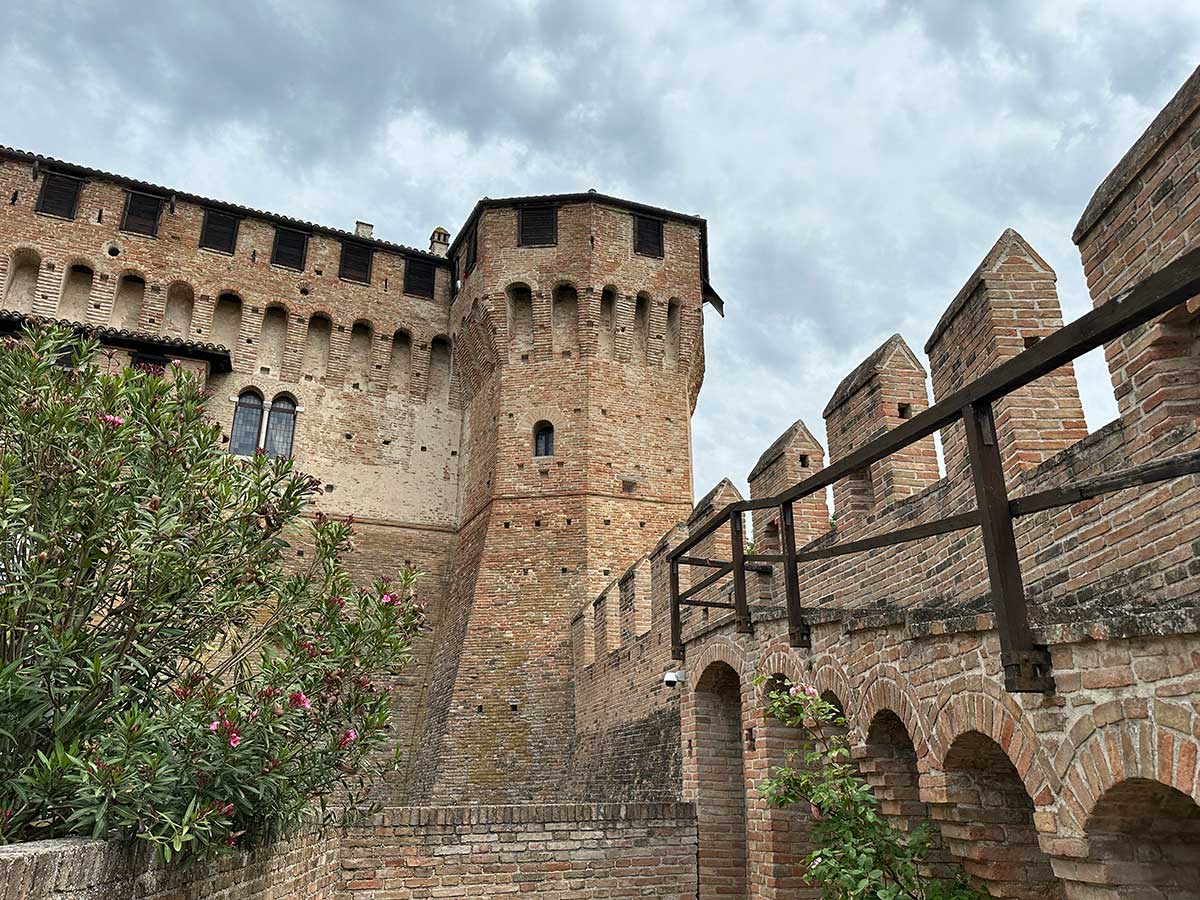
<box><xmin>691</xmin><ymin>662</ymin><xmax>748</xmax><ymax>900</ymax></box>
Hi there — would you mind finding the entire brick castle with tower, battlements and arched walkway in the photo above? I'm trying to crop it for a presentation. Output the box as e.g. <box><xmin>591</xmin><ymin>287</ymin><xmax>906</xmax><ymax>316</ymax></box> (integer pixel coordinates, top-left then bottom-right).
<box><xmin>0</xmin><ymin>70</ymin><xmax>1200</xmax><ymax>900</ymax></box>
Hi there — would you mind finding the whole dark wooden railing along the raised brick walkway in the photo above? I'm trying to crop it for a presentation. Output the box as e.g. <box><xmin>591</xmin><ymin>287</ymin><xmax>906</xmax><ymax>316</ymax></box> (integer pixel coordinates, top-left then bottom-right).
<box><xmin>668</xmin><ymin>250</ymin><xmax>1200</xmax><ymax>692</ymax></box>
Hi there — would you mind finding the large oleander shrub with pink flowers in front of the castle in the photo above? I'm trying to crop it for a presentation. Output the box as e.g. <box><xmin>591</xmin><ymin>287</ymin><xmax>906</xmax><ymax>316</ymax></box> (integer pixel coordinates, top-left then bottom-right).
<box><xmin>0</xmin><ymin>330</ymin><xmax>422</xmax><ymax>860</ymax></box>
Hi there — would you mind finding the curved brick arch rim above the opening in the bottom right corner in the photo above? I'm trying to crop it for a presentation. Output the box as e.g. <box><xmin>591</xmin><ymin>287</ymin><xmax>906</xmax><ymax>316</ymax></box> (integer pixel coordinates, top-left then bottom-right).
<box><xmin>1060</xmin><ymin>701</ymin><xmax>1200</xmax><ymax>836</ymax></box>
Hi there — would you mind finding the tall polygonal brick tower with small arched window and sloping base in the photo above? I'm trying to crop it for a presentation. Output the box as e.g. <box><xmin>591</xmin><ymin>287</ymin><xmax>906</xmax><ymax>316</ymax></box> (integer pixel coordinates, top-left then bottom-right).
<box><xmin>413</xmin><ymin>192</ymin><xmax>720</xmax><ymax>803</ymax></box>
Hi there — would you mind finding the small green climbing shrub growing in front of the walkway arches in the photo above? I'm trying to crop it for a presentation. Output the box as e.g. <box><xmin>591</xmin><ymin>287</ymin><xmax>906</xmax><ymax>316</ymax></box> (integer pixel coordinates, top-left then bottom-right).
<box><xmin>760</xmin><ymin>679</ymin><xmax>986</xmax><ymax>900</ymax></box>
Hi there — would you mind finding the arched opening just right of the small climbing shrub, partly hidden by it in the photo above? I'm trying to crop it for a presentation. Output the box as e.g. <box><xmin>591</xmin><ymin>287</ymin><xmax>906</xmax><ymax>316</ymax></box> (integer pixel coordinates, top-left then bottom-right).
<box><xmin>858</xmin><ymin>709</ymin><xmax>949</xmax><ymax>868</ymax></box>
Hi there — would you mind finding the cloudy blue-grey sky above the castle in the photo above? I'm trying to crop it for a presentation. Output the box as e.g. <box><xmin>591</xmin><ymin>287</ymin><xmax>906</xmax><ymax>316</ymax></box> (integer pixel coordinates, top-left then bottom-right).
<box><xmin>0</xmin><ymin>0</ymin><xmax>1200</xmax><ymax>493</ymax></box>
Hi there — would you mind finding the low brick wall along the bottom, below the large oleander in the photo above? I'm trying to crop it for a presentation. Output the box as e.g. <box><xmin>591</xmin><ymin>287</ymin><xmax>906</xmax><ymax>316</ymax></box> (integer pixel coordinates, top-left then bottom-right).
<box><xmin>0</xmin><ymin>803</ymin><xmax>696</xmax><ymax>900</ymax></box>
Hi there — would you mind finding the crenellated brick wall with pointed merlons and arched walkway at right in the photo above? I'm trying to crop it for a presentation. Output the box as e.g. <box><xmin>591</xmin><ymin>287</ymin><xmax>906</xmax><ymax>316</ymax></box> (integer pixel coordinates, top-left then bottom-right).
<box><xmin>571</xmin><ymin>63</ymin><xmax>1200</xmax><ymax>900</ymax></box>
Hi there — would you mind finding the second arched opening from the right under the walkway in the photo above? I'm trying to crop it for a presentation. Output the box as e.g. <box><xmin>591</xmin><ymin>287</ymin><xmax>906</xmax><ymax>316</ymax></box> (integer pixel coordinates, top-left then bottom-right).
<box><xmin>935</xmin><ymin>731</ymin><xmax>1063</xmax><ymax>900</ymax></box>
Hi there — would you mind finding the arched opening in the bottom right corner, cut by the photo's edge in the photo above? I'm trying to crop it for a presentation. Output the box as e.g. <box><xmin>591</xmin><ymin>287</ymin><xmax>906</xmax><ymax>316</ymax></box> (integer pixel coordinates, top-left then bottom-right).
<box><xmin>1080</xmin><ymin>778</ymin><xmax>1200</xmax><ymax>900</ymax></box>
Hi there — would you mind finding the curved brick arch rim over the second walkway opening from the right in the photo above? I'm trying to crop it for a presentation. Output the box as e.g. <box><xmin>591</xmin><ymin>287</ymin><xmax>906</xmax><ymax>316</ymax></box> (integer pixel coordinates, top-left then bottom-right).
<box><xmin>928</xmin><ymin>677</ymin><xmax>1061</xmax><ymax>808</ymax></box>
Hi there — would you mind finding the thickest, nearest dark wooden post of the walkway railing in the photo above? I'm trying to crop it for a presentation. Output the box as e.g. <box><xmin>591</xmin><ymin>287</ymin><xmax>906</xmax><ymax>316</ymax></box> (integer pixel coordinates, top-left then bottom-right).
<box><xmin>962</xmin><ymin>401</ymin><xmax>1054</xmax><ymax>692</ymax></box>
